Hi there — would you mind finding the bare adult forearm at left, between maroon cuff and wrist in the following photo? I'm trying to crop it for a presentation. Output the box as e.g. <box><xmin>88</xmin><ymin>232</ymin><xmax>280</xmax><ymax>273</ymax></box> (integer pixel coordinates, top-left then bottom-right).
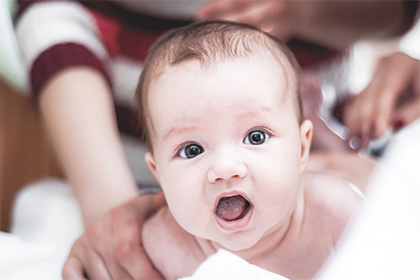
<box><xmin>40</xmin><ymin>67</ymin><xmax>137</xmax><ymax>226</ymax></box>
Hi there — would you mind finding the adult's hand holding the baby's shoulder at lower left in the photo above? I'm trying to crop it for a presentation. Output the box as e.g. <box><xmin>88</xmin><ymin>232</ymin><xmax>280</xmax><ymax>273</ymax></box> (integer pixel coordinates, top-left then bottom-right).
<box><xmin>62</xmin><ymin>194</ymin><xmax>165</xmax><ymax>280</ymax></box>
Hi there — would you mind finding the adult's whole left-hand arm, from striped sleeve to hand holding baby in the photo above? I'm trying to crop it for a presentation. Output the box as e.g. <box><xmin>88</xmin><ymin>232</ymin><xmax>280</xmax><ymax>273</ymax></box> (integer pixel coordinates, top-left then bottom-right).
<box><xmin>16</xmin><ymin>1</ymin><xmax>162</xmax><ymax>279</ymax></box>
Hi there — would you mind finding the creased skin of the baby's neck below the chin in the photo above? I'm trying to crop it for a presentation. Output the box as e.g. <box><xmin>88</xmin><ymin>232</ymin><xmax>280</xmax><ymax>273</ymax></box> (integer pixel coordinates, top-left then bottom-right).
<box><xmin>196</xmin><ymin>187</ymin><xmax>305</xmax><ymax>264</ymax></box>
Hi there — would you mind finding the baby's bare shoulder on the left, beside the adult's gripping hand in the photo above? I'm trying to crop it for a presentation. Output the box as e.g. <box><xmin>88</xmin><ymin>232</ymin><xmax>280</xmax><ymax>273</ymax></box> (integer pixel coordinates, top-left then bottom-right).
<box><xmin>142</xmin><ymin>207</ymin><xmax>205</xmax><ymax>279</ymax></box>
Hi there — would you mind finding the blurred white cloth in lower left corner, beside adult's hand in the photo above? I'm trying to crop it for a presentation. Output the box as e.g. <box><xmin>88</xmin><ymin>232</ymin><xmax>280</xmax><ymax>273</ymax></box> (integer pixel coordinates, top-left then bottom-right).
<box><xmin>0</xmin><ymin>179</ymin><xmax>83</xmax><ymax>280</ymax></box>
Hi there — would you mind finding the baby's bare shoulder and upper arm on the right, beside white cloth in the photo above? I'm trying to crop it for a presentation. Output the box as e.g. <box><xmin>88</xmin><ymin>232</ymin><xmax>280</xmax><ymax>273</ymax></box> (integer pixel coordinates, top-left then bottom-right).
<box><xmin>266</xmin><ymin>172</ymin><xmax>363</xmax><ymax>280</ymax></box>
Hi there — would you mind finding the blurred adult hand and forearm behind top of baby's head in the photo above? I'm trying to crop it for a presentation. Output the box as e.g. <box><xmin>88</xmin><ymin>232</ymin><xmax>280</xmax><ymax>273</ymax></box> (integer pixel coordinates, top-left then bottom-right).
<box><xmin>196</xmin><ymin>0</ymin><xmax>407</xmax><ymax>49</ymax></box>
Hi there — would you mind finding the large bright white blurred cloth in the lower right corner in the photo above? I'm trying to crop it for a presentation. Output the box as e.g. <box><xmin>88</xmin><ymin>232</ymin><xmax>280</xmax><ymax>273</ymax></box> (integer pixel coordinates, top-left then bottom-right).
<box><xmin>317</xmin><ymin>120</ymin><xmax>420</xmax><ymax>280</ymax></box>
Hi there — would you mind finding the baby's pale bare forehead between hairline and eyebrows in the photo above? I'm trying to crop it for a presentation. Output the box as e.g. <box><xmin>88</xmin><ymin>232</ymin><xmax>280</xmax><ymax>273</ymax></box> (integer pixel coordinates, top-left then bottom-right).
<box><xmin>146</xmin><ymin>52</ymin><xmax>297</xmax><ymax>147</ymax></box>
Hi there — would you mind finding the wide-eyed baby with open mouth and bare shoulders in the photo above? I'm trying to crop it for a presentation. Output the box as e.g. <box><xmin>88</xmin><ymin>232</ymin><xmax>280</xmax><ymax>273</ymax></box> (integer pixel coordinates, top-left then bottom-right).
<box><xmin>137</xmin><ymin>21</ymin><xmax>362</xmax><ymax>279</ymax></box>
